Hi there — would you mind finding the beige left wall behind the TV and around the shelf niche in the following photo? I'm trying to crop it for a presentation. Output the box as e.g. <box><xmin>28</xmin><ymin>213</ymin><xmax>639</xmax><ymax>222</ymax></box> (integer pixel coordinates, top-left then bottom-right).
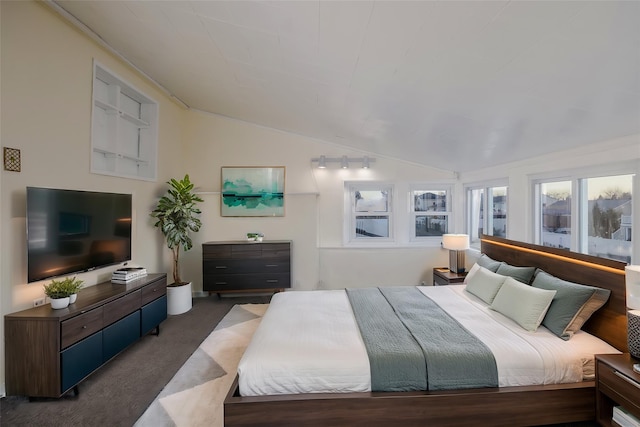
<box><xmin>0</xmin><ymin>1</ymin><xmax>185</xmax><ymax>392</ymax></box>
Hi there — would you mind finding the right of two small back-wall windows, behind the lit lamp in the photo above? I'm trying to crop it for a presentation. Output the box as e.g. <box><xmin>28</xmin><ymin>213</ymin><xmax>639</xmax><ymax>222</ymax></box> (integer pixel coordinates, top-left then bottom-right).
<box><xmin>411</xmin><ymin>186</ymin><xmax>451</xmax><ymax>241</ymax></box>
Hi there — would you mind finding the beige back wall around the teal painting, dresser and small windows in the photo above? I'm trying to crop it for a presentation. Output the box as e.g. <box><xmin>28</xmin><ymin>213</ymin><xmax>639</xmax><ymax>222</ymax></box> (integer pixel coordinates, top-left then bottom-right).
<box><xmin>183</xmin><ymin>111</ymin><xmax>453</xmax><ymax>291</ymax></box>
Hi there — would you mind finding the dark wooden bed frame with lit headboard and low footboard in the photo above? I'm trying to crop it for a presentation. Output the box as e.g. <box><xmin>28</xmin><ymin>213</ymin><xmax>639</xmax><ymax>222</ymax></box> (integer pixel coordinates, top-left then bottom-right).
<box><xmin>224</xmin><ymin>236</ymin><xmax>627</xmax><ymax>427</ymax></box>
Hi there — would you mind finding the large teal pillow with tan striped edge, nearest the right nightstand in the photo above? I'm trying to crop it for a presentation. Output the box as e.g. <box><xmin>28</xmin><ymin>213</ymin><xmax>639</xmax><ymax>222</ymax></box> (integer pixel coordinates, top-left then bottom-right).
<box><xmin>531</xmin><ymin>270</ymin><xmax>611</xmax><ymax>341</ymax></box>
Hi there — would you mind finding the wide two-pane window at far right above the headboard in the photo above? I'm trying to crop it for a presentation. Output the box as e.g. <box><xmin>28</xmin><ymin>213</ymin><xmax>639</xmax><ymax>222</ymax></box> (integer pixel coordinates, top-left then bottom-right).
<box><xmin>535</xmin><ymin>174</ymin><xmax>634</xmax><ymax>263</ymax></box>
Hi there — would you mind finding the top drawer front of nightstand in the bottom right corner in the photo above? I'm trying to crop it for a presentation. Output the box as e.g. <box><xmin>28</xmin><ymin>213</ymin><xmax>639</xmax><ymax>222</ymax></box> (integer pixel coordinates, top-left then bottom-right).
<box><xmin>598</xmin><ymin>361</ymin><xmax>640</xmax><ymax>417</ymax></box>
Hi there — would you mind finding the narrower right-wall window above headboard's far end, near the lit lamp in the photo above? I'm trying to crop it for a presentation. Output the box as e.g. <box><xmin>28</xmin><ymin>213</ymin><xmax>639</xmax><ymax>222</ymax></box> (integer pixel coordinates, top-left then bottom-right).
<box><xmin>466</xmin><ymin>186</ymin><xmax>508</xmax><ymax>248</ymax></box>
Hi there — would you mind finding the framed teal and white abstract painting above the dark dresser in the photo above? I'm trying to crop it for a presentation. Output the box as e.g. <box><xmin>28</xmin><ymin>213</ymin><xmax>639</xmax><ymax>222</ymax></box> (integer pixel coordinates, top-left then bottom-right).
<box><xmin>220</xmin><ymin>166</ymin><xmax>285</xmax><ymax>217</ymax></box>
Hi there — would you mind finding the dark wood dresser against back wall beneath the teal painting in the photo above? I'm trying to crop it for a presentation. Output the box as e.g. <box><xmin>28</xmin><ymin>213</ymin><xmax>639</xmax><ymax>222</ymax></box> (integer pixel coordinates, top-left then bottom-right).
<box><xmin>202</xmin><ymin>240</ymin><xmax>291</xmax><ymax>296</ymax></box>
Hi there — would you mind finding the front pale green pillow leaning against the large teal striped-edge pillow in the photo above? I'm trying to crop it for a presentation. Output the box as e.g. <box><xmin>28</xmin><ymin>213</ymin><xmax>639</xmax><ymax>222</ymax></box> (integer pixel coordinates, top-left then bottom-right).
<box><xmin>490</xmin><ymin>277</ymin><xmax>556</xmax><ymax>332</ymax></box>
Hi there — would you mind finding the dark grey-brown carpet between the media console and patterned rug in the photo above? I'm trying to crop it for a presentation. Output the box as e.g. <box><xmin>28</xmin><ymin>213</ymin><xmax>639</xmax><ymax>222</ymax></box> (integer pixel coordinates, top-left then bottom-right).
<box><xmin>0</xmin><ymin>296</ymin><xmax>270</xmax><ymax>427</ymax></box>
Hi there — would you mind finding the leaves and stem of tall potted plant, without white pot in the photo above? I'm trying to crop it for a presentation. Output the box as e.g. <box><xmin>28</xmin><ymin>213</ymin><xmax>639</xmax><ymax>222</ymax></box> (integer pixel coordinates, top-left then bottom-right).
<box><xmin>150</xmin><ymin>175</ymin><xmax>203</xmax><ymax>285</ymax></box>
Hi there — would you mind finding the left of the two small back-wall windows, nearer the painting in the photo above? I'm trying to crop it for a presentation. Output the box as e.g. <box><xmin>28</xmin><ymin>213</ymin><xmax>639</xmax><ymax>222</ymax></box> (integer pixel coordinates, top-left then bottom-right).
<box><xmin>347</xmin><ymin>183</ymin><xmax>393</xmax><ymax>243</ymax></box>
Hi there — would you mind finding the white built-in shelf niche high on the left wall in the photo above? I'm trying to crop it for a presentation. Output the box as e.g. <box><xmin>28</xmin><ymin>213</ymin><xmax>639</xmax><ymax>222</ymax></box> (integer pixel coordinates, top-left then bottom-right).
<box><xmin>91</xmin><ymin>61</ymin><xmax>158</xmax><ymax>181</ymax></box>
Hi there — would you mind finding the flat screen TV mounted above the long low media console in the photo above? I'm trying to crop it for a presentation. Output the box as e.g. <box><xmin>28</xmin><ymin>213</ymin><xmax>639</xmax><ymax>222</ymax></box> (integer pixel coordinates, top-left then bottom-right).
<box><xmin>27</xmin><ymin>187</ymin><xmax>132</xmax><ymax>282</ymax></box>
